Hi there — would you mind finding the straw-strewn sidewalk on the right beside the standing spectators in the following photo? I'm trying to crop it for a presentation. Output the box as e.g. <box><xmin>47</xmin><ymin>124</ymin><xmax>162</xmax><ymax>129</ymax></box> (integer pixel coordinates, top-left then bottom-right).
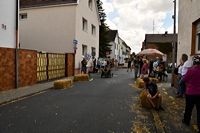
<box><xmin>153</xmin><ymin>74</ymin><xmax>197</xmax><ymax>133</ymax></box>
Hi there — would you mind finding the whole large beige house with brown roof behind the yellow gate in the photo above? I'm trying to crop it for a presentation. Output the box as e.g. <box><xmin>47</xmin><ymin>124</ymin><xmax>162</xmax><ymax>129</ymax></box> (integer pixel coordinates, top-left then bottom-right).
<box><xmin>19</xmin><ymin>0</ymin><xmax>100</xmax><ymax>74</ymax></box>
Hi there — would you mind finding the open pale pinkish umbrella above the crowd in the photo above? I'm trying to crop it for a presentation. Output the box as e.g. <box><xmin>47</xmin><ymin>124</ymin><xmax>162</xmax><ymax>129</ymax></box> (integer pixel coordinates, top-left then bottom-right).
<box><xmin>137</xmin><ymin>49</ymin><xmax>164</xmax><ymax>56</ymax></box>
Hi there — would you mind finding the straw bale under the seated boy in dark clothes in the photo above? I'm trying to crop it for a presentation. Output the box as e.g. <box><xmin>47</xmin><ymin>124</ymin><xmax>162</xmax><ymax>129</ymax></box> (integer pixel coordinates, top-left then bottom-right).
<box><xmin>140</xmin><ymin>90</ymin><xmax>162</xmax><ymax>108</ymax></box>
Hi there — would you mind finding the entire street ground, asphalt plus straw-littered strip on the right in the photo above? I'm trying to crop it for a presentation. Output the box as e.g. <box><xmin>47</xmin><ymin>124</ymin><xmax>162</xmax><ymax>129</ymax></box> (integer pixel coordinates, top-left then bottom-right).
<box><xmin>0</xmin><ymin>69</ymin><xmax>196</xmax><ymax>133</ymax></box>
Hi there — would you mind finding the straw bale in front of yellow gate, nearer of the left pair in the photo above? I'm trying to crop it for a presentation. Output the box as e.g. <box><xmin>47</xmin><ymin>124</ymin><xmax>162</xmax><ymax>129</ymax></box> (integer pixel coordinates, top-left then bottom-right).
<box><xmin>53</xmin><ymin>79</ymin><xmax>72</xmax><ymax>89</ymax></box>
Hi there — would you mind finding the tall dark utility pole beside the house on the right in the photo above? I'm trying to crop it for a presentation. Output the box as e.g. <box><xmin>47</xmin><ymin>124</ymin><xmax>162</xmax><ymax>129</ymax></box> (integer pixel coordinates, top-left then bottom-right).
<box><xmin>171</xmin><ymin>0</ymin><xmax>176</xmax><ymax>87</ymax></box>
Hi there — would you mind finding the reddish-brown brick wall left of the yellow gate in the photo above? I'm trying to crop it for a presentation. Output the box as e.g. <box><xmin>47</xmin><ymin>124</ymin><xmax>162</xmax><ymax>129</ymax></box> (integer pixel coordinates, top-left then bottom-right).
<box><xmin>0</xmin><ymin>48</ymin><xmax>37</xmax><ymax>91</ymax></box>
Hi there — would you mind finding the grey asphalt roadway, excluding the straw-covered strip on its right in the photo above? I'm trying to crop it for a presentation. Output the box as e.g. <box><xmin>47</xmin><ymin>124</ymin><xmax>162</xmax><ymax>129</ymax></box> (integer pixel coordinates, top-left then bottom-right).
<box><xmin>0</xmin><ymin>69</ymin><xmax>156</xmax><ymax>133</ymax></box>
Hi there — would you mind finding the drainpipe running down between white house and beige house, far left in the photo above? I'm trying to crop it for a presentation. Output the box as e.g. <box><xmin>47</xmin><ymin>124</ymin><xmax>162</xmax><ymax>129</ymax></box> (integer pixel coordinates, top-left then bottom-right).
<box><xmin>15</xmin><ymin>0</ymin><xmax>19</xmax><ymax>89</ymax></box>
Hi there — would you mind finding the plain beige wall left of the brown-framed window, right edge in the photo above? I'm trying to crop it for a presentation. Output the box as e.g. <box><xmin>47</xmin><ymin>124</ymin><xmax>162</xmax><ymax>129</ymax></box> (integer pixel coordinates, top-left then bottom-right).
<box><xmin>177</xmin><ymin>0</ymin><xmax>200</xmax><ymax>61</ymax></box>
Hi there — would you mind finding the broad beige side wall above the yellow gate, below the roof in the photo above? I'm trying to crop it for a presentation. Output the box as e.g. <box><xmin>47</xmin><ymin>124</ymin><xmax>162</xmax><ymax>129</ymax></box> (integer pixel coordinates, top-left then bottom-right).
<box><xmin>19</xmin><ymin>5</ymin><xmax>76</xmax><ymax>53</ymax></box>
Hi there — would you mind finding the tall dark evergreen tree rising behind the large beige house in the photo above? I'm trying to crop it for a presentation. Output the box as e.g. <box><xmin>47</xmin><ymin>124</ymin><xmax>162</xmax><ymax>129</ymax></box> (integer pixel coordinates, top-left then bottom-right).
<box><xmin>97</xmin><ymin>0</ymin><xmax>112</xmax><ymax>58</ymax></box>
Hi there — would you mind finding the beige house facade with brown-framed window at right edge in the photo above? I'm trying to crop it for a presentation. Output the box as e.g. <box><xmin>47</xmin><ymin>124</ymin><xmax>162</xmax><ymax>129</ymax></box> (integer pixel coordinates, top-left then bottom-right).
<box><xmin>177</xmin><ymin>0</ymin><xmax>200</xmax><ymax>61</ymax></box>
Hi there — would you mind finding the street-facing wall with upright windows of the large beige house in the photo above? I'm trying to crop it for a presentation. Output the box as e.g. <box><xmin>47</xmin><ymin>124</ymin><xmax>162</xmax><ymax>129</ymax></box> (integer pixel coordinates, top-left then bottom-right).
<box><xmin>75</xmin><ymin>0</ymin><xmax>99</xmax><ymax>68</ymax></box>
